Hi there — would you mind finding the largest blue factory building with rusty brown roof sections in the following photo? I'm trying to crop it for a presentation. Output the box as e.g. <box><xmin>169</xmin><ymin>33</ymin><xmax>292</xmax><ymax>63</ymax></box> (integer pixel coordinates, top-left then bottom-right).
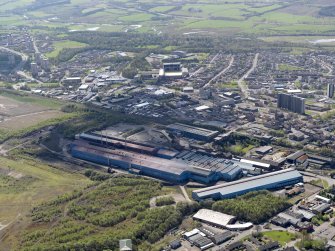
<box><xmin>71</xmin><ymin>134</ymin><xmax>252</xmax><ymax>184</ymax></box>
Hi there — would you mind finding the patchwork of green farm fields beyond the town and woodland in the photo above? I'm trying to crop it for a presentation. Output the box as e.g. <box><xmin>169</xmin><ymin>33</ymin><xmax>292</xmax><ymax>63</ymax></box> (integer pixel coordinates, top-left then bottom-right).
<box><xmin>0</xmin><ymin>0</ymin><xmax>335</xmax><ymax>36</ymax></box>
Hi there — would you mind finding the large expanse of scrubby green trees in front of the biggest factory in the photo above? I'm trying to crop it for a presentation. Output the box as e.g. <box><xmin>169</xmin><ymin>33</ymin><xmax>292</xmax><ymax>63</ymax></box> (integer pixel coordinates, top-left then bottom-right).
<box><xmin>19</xmin><ymin>176</ymin><xmax>199</xmax><ymax>251</ymax></box>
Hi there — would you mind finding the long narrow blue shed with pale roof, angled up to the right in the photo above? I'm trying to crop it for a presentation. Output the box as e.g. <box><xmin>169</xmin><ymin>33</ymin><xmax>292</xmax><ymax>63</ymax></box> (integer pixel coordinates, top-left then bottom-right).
<box><xmin>192</xmin><ymin>169</ymin><xmax>303</xmax><ymax>201</ymax></box>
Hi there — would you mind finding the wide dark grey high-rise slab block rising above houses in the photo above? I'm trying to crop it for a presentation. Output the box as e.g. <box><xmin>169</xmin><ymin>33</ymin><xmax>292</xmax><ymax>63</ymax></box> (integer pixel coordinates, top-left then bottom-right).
<box><xmin>277</xmin><ymin>93</ymin><xmax>305</xmax><ymax>114</ymax></box>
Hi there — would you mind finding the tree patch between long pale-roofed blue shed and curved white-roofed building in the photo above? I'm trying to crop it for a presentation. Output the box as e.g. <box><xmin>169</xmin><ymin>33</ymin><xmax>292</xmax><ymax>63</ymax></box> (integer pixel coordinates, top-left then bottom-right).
<box><xmin>212</xmin><ymin>191</ymin><xmax>291</xmax><ymax>224</ymax></box>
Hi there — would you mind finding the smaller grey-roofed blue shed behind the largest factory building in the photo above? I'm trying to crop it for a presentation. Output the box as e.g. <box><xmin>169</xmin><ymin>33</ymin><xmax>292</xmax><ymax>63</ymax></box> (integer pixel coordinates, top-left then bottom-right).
<box><xmin>166</xmin><ymin>123</ymin><xmax>219</xmax><ymax>141</ymax></box>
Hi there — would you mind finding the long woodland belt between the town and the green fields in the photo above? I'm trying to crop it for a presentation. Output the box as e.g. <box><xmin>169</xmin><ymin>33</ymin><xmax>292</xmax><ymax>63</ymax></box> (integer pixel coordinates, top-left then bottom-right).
<box><xmin>49</xmin><ymin>29</ymin><xmax>289</xmax><ymax>68</ymax></box>
